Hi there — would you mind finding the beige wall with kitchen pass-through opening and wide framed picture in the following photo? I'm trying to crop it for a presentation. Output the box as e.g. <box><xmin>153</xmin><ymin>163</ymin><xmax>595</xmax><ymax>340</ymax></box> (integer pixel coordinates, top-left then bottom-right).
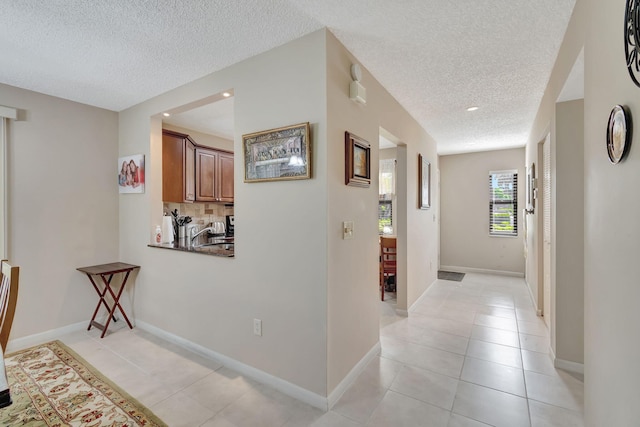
<box><xmin>120</xmin><ymin>32</ymin><xmax>327</xmax><ymax>396</ymax></box>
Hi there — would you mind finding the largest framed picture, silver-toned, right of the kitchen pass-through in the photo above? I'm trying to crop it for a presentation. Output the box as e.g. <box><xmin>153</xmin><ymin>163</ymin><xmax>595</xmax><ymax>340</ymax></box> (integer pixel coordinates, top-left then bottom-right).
<box><xmin>242</xmin><ymin>122</ymin><xmax>311</xmax><ymax>182</ymax></box>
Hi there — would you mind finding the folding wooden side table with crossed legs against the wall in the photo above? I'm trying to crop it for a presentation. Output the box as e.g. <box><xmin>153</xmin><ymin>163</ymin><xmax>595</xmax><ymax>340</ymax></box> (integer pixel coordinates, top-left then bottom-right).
<box><xmin>77</xmin><ymin>262</ymin><xmax>140</xmax><ymax>338</ymax></box>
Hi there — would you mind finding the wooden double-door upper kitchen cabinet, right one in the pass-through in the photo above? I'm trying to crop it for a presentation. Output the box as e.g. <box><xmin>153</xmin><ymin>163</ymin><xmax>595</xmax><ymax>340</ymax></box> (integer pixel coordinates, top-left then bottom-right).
<box><xmin>195</xmin><ymin>147</ymin><xmax>233</xmax><ymax>203</ymax></box>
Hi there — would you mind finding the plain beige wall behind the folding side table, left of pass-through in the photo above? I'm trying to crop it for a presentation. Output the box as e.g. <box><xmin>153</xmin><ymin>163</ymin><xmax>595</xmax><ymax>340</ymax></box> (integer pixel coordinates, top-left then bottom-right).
<box><xmin>0</xmin><ymin>84</ymin><xmax>120</xmax><ymax>340</ymax></box>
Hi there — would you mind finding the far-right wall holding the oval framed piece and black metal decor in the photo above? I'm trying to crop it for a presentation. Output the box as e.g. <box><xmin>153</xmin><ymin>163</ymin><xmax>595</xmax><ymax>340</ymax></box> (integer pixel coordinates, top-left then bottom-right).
<box><xmin>584</xmin><ymin>0</ymin><xmax>640</xmax><ymax>426</ymax></box>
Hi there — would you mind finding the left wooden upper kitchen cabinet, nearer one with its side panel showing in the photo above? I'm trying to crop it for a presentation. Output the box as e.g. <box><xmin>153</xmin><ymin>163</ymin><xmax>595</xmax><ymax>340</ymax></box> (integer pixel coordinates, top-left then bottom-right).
<box><xmin>162</xmin><ymin>130</ymin><xmax>196</xmax><ymax>203</ymax></box>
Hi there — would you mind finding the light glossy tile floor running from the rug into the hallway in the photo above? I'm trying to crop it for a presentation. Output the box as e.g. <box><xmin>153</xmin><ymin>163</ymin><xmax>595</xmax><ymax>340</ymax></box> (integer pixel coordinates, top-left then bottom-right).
<box><xmin>42</xmin><ymin>274</ymin><xmax>583</xmax><ymax>427</ymax></box>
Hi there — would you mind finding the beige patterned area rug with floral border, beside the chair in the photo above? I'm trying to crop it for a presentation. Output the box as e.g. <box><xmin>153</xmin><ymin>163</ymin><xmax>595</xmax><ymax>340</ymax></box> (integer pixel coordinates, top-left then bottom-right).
<box><xmin>0</xmin><ymin>341</ymin><xmax>166</xmax><ymax>427</ymax></box>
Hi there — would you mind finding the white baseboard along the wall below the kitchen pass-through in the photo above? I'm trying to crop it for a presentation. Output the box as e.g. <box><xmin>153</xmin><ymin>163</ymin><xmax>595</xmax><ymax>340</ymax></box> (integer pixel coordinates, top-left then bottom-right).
<box><xmin>136</xmin><ymin>319</ymin><xmax>330</xmax><ymax>411</ymax></box>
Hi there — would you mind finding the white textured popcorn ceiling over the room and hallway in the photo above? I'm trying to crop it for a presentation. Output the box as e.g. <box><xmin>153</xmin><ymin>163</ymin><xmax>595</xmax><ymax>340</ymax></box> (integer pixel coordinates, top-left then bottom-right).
<box><xmin>0</xmin><ymin>0</ymin><xmax>575</xmax><ymax>154</ymax></box>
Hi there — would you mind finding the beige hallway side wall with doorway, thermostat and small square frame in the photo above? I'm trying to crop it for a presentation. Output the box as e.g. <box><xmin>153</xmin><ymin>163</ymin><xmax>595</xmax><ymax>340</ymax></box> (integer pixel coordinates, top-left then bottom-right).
<box><xmin>327</xmin><ymin>33</ymin><xmax>438</xmax><ymax>392</ymax></box>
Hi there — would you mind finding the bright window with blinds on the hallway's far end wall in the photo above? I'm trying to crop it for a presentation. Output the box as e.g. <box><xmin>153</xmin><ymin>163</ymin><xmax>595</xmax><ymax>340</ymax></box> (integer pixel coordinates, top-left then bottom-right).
<box><xmin>489</xmin><ymin>170</ymin><xmax>518</xmax><ymax>236</ymax></box>
